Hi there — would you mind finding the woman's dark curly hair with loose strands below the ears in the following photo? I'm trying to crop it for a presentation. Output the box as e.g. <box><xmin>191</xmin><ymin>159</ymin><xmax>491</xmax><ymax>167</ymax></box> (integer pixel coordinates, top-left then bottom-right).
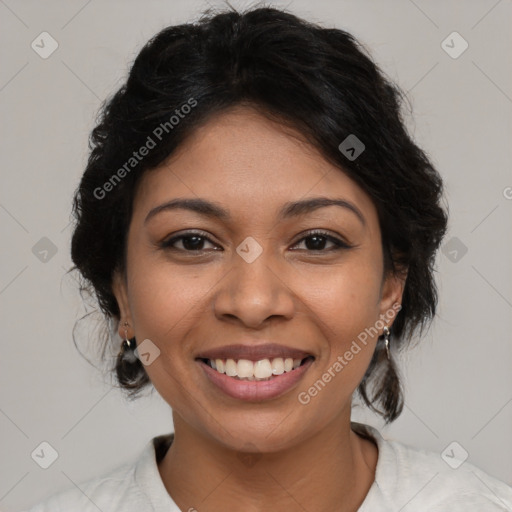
<box><xmin>71</xmin><ymin>7</ymin><xmax>447</xmax><ymax>423</ymax></box>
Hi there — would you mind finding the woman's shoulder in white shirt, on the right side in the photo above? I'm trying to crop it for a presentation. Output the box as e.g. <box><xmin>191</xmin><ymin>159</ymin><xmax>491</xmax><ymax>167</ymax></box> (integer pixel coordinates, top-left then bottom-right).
<box><xmin>356</xmin><ymin>424</ymin><xmax>512</xmax><ymax>512</ymax></box>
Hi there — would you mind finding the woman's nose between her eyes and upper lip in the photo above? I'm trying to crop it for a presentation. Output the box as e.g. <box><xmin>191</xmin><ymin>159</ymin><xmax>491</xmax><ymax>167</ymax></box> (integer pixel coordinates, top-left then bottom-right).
<box><xmin>213</xmin><ymin>250</ymin><xmax>296</xmax><ymax>329</ymax></box>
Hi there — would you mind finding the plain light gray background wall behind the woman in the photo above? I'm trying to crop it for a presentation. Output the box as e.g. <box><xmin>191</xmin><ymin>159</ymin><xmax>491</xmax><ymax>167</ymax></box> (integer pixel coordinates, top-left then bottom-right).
<box><xmin>0</xmin><ymin>0</ymin><xmax>512</xmax><ymax>511</ymax></box>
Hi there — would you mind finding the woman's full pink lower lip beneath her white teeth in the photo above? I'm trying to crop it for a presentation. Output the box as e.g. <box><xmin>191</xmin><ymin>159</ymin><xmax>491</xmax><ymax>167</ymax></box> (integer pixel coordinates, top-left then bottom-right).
<box><xmin>197</xmin><ymin>359</ymin><xmax>314</xmax><ymax>402</ymax></box>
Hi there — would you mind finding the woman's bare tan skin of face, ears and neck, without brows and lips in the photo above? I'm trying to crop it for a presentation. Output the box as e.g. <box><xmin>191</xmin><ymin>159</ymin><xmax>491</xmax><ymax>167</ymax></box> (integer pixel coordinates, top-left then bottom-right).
<box><xmin>114</xmin><ymin>106</ymin><xmax>404</xmax><ymax>512</ymax></box>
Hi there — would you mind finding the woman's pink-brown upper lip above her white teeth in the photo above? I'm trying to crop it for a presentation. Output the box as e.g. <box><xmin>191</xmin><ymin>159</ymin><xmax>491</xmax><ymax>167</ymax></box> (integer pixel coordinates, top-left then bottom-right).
<box><xmin>196</xmin><ymin>343</ymin><xmax>312</xmax><ymax>361</ymax></box>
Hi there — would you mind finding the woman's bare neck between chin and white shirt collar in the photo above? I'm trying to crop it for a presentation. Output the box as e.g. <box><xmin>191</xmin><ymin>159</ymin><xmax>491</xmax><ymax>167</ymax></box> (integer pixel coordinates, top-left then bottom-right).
<box><xmin>159</xmin><ymin>412</ymin><xmax>378</xmax><ymax>512</ymax></box>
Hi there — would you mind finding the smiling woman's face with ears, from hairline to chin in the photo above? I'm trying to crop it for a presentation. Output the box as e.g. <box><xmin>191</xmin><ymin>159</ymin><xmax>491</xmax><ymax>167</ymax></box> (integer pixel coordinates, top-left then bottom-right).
<box><xmin>114</xmin><ymin>107</ymin><xmax>403</xmax><ymax>452</ymax></box>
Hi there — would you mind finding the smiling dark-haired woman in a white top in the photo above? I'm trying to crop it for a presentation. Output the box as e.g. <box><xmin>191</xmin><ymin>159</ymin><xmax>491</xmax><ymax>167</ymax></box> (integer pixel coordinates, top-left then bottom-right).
<box><xmin>27</xmin><ymin>8</ymin><xmax>512</xmax><ymax>512</ymax></box>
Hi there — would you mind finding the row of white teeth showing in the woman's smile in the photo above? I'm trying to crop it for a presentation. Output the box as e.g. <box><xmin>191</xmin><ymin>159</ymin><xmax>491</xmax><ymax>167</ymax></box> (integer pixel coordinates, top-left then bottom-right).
<box><xmin>197</xmin><ymin>356</ymin><xmax>315</xmax><ymax>381</ymax></box>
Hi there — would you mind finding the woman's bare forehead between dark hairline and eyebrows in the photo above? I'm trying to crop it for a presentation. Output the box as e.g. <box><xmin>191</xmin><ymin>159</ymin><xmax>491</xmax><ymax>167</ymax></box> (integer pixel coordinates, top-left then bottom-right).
<box><xmin>135</xmin><ymin>107</ymin><xmax>376</xmax><ymax>226</ymax></box>
